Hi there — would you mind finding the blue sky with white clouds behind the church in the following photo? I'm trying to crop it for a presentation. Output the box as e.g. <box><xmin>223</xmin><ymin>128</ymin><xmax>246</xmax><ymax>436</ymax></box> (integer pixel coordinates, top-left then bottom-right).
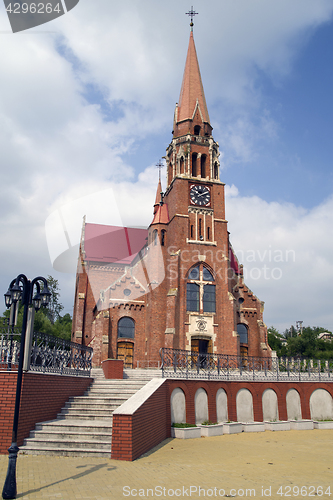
<box><xmin>0</xmin><ymin>0</ymin><xmax>333</xmax><ymax>332</ymax></box>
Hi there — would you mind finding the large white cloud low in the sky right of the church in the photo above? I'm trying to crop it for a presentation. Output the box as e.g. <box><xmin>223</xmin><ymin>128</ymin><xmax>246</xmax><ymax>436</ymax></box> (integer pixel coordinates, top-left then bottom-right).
<box><xmin>226</xmin><ymin>190</ymin><xmax>333</xmax><ymax>330</ymax></box>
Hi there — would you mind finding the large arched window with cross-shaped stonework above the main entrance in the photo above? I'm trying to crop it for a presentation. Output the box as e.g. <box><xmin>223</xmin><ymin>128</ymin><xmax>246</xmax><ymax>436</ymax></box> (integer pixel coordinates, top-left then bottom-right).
<box><xmin>186</xmin><ymin>264</ymin><xmax>216</xmax><ymax>313</ymax></box>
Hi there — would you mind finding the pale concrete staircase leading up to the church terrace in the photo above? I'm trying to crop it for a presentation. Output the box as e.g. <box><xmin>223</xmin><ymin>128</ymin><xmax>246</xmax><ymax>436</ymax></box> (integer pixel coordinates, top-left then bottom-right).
<box><xmin>20</xmin><ymin>368</ymin><xmax>162</xmax><ymax>458</ymax></box>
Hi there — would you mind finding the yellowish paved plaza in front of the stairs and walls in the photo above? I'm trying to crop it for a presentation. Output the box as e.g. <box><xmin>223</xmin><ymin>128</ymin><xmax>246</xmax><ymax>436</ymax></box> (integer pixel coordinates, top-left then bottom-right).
<box><xmin>0</xmin><ymin>430</ymin><xmax>333</xmax><ymax>500</ymax></box>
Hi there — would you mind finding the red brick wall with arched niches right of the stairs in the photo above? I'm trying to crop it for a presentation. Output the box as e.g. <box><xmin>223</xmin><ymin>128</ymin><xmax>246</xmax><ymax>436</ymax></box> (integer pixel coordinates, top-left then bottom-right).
<box><xmin>111</xmin><ymin>379</ymin><xmax>333</xmax><ymax>461</ymax></box>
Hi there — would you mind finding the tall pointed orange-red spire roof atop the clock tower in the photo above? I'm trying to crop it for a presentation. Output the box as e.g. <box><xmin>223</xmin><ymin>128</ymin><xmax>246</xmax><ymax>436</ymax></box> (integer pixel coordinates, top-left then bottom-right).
<box><xmin>176</xmin><ymin>31</ymin><xmax>210</xmax><ymax>123</ymax></box>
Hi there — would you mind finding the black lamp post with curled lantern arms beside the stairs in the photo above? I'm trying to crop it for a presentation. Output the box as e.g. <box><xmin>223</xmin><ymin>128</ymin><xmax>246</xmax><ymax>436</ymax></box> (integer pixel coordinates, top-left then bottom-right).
<box><xmin>2</xmin><ymin>274</ymin><xmax>51</xmax><ymax>499</ymax></box>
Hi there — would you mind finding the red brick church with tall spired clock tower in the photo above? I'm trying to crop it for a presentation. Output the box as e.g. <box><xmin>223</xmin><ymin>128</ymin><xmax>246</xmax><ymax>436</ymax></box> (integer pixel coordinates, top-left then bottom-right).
<box><xmin>72</xmin><ymin>29</ymin><xmax>271</xmax><ymax>368</ymax></box>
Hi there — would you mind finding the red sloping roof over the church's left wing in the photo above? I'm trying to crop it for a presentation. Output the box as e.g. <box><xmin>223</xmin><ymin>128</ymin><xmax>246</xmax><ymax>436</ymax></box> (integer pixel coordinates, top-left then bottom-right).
<box><xmin>84</xmin><ymin>223</ymin><xmax>148</xmax><ymax>265</ymax></box>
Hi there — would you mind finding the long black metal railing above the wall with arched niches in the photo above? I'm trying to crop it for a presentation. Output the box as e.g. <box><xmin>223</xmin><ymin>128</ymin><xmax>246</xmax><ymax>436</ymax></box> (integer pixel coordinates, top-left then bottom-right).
<box><xmin>160</xmin><ymin>348</ymin><xmax>333</xmax><ymax>382</ymax></box>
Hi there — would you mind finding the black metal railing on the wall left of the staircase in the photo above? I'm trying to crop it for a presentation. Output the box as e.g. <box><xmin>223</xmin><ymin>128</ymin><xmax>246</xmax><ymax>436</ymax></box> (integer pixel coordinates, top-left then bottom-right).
<box><xmin>0</xmin><ymin>328</ymin><xmax>93</xmax><ymax>377</ymax></box>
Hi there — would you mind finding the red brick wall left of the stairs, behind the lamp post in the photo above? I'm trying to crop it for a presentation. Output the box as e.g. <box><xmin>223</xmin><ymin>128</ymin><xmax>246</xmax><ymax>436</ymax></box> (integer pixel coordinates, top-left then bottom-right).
<box><xmin>0</xmin><ymin>372</ymin><xmax>92</xmax><ymax>454</ymax></box>
